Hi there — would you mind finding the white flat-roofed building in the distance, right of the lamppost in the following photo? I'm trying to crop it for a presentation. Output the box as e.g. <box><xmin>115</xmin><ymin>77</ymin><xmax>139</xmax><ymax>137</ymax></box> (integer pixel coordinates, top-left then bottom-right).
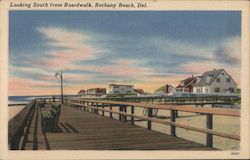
<box><xmin>108</xmin><ymin>84</ymin><xmax>134</xmax><ymax>94</ymax></box>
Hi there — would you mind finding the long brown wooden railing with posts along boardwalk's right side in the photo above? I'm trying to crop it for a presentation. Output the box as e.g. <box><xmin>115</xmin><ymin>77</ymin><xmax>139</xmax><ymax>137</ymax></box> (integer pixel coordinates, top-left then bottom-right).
<box><xmin>65</xmin><ymin>99</ymin><xmax>240</xmax><ymax>147</ymax></box>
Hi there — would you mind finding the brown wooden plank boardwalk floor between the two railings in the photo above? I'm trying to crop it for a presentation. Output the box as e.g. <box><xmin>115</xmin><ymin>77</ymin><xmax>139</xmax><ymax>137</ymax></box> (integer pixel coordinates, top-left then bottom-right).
<box><xmin>22</xmin><ymin>105</ymin><xmax>212</xmax><ymax>150</ymax></box>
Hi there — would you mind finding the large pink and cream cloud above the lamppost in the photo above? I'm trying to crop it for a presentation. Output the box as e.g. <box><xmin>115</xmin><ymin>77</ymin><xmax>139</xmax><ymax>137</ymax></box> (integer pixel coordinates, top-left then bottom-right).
<box><xmin>37</xmin><ymin>27</ymin><xmax>101</xmax><ymax>70</ymax></box>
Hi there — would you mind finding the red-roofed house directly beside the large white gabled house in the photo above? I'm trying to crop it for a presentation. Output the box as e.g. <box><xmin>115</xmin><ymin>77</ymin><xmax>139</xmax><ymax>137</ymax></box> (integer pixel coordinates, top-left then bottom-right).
<box><xmin>175</xmin><ymin>76</ymin><xmax>199</xmax><ymax>92</ymax></box>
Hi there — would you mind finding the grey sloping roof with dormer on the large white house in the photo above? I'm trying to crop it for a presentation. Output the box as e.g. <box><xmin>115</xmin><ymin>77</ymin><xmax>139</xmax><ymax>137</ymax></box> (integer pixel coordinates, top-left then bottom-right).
<box><xmin>194</xmin><ymin>69</ymin><xmax>224</xmax><ymax>87</ymax></box>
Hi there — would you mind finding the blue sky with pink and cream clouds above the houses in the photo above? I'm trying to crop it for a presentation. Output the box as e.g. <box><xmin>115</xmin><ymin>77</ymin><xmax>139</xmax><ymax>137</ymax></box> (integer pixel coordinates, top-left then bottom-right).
<box><xmin>9</xmin><ymin>11</ymin><xmax>241</xmax><ymax>95</ymax></box>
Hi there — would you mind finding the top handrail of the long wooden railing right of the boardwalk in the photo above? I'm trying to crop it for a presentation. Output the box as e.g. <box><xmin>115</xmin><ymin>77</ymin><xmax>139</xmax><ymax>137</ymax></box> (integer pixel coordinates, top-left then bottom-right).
<box><xmin>68</xmin><ymin>99</ymin><xmax>240</xmax><ymax>117</ymax></box>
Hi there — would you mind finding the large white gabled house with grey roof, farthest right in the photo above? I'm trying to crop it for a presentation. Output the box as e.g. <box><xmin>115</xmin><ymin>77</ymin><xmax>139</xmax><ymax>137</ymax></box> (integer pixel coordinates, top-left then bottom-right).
<box><xmin>194</xmin><ymin>69</ymin><xmax>237</xmax><ymax>93</ymax></box>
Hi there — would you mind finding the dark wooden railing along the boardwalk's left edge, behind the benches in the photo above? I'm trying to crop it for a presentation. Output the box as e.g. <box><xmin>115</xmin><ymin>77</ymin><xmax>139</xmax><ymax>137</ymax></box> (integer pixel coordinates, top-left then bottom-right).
<box><xmin>8</xmin><ymin>100</ymin><xmax>36</xmax><ymax>149</ymax></box>
